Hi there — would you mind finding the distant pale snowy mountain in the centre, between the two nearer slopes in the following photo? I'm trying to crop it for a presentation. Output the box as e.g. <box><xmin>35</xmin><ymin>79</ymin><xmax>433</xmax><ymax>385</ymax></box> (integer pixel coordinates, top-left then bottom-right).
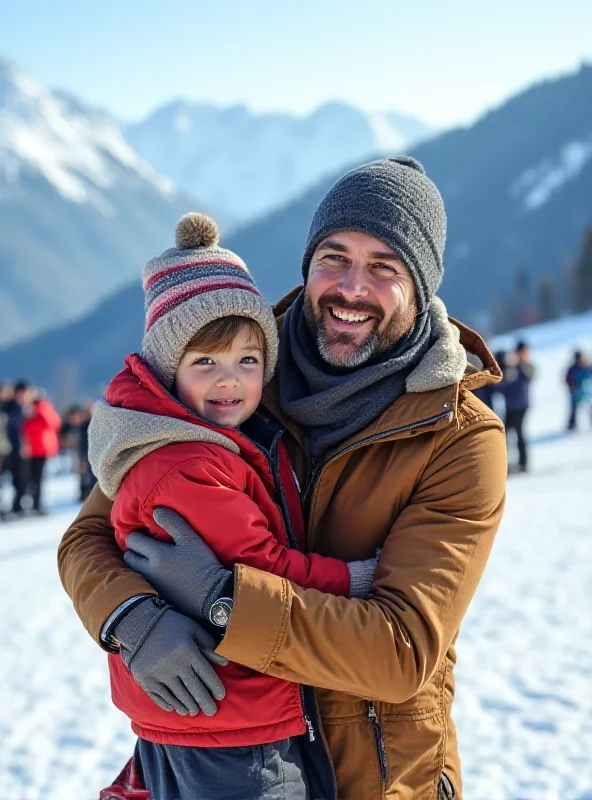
<box><xmin>124</xmin><ymin>101</ymin><xmax>431</xmax><ymax>222</ymax></box>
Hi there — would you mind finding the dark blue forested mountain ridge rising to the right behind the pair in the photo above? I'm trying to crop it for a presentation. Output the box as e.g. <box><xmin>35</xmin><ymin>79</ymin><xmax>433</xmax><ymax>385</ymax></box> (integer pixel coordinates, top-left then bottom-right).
<box><xmin>0</xmin><ymin>66</ymin><xmax>592</xmax><ymax>394</ymax></box>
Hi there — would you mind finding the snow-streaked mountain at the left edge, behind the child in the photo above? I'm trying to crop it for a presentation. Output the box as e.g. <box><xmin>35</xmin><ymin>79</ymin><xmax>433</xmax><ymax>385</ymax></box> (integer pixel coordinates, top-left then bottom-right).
<box><xmin>0</xmin><ymin>60</ymin><xmax>202</xmax><ymax>346</ymax></box>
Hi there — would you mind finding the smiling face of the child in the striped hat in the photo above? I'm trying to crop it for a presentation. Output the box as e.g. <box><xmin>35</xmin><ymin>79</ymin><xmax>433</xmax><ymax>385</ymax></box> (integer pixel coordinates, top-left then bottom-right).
<box><xmin>175</xmin><ymin>324</ymin><xmax>264</xmax><ymax>428</ymax></box>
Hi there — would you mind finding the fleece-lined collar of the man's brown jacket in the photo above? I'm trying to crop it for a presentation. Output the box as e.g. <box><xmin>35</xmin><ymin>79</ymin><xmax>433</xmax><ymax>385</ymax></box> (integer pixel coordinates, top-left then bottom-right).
<box><xmin>262</xmin><ymin>286</ymin><xmax>502</xmax><ymax>450</ymax></box>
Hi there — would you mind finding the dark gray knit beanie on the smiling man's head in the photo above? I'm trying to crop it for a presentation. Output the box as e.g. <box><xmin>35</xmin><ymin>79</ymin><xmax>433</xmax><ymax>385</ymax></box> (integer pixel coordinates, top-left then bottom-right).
<box><xmin>302</xmin><ymin>156</ymin><xmax>446</xmax><ymax>311</ymax></box>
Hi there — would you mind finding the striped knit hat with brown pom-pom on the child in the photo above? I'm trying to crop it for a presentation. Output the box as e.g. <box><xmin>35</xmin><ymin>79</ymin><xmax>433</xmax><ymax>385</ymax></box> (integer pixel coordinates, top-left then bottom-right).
<box><xmin>142</xmin><ymin>213</ymin><xmax>278</xmax><ymax>389</ymax></box>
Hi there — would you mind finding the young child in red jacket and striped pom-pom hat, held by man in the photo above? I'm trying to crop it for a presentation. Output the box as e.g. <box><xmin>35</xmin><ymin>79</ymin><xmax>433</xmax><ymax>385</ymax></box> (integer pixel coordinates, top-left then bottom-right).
<box><xmin>90</xmin><ymin>214</ymin><xmax>376</xmax><ymax>800</ymax></box>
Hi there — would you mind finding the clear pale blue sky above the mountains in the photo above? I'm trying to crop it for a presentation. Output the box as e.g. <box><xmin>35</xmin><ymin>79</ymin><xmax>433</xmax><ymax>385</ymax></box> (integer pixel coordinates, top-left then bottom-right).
<box><xmin>0</xmin><ymin>0</ymin><xmax>592</xmax><ymax>127</ymax></box>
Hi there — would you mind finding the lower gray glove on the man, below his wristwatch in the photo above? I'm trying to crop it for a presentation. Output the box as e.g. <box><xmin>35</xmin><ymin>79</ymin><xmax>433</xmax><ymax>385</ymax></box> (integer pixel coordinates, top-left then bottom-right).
<box><xmin>113</xmin><ymin>597</ymin><xmax>228</xmax><ymax>716</ymax></box>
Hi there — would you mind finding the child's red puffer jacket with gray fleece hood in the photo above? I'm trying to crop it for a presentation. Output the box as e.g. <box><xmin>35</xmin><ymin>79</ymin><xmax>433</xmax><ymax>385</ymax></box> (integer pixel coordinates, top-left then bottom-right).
<box><xmin>91</xmin><ymin>355</ymin><xmax>350</xmax><ymax>747</ymax></box>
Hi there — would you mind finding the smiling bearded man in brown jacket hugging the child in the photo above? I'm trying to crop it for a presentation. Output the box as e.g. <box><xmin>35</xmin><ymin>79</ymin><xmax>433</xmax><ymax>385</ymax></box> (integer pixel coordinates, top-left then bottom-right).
<box><xmin>59</xmin><ymin>157</ymin><xmax>506</xmax><ymax>800</ymax></box>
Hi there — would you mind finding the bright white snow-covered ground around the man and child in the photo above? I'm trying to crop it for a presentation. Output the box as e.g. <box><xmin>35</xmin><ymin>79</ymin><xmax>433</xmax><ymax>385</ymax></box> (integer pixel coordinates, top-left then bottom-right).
<box><xmin>0</xmin><ymin>315</ymin><xmax>592</xmax><ymax>800</ymax></box>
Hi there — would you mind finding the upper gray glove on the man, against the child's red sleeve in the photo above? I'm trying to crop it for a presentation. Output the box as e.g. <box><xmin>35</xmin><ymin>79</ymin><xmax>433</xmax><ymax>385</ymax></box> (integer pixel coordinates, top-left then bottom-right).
<box><xmin>123</xmin><ymin>508</ymin><xmax>233</xmax><ymax>620</ymax></box>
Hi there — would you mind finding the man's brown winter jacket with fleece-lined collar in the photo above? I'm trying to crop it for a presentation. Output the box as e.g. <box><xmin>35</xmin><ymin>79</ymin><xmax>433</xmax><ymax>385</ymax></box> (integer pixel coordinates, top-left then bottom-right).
<box><xmin>59</xmin><ymin>293</ymin><xmax>506</xmax><ymax>800</ymax></box>
